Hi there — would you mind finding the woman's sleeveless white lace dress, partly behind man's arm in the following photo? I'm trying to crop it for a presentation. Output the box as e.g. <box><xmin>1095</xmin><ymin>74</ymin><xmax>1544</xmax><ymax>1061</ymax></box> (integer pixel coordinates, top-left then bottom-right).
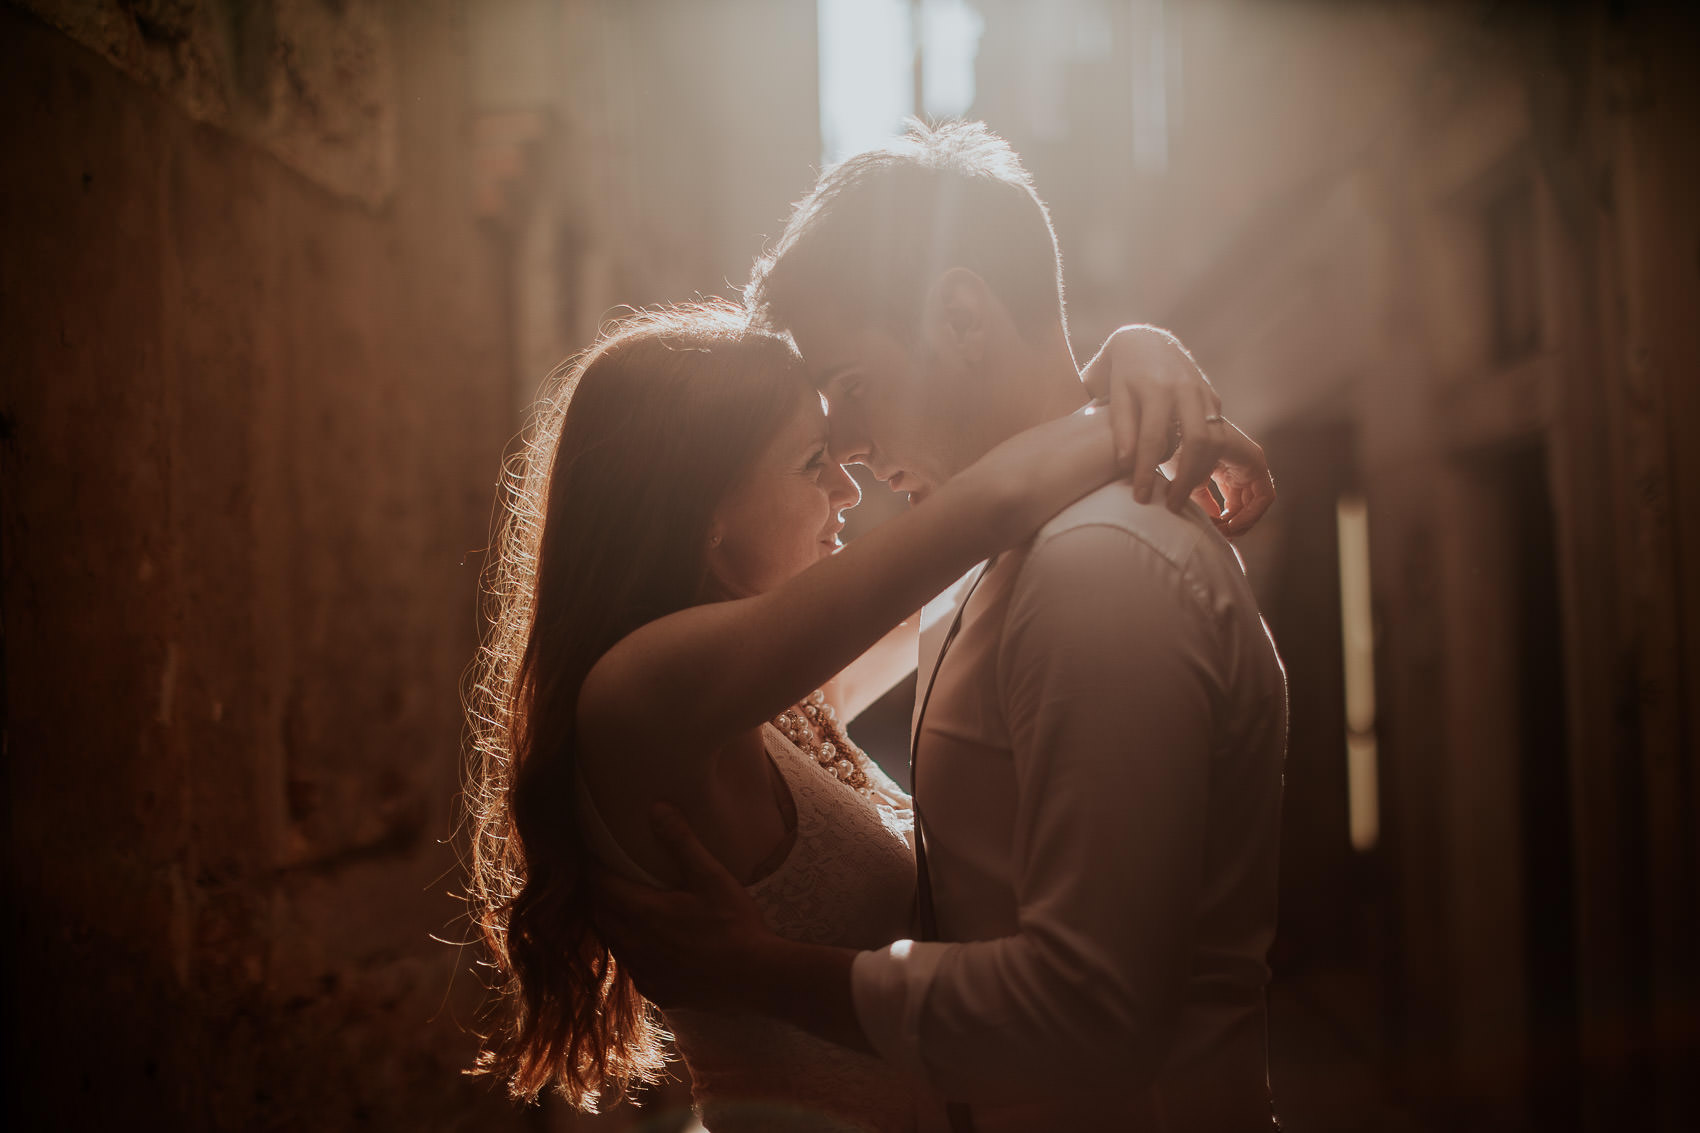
<box><xmin>580</xmin><ymin>725</ymin><xmax>915</xmax><ymax>1133</ymax></box>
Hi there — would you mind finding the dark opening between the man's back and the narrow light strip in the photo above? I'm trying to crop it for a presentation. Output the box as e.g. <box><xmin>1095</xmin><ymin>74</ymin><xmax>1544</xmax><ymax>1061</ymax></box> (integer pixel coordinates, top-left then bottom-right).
<box><xmin>1241</xmin><ymin>420</ymin><xmax>1400</xmax><ymax>1133</ymax></box>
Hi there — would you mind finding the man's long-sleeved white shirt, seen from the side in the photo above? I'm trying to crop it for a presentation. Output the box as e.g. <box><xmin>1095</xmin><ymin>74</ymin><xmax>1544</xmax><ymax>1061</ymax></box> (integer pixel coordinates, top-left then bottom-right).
<box><xmin>852</xmin><ymin>472</ymin><xmax>1287</xmax><ymax>1133</ymax></box>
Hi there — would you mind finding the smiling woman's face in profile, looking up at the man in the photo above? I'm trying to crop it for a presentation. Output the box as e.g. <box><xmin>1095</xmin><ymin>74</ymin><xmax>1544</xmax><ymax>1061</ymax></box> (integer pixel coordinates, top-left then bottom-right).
<box><xmin>709</xmin><ymin>381</ymin><xmax>862</xmax><ymax>597</ymax></box>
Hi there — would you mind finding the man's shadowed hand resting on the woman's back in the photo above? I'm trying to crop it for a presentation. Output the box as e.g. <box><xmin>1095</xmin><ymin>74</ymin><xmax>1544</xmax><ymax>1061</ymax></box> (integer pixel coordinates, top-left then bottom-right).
<box><xmin>595</xmin><ymin>805</ymin><xmax>780</xmax><ymax>1009</ymax></box>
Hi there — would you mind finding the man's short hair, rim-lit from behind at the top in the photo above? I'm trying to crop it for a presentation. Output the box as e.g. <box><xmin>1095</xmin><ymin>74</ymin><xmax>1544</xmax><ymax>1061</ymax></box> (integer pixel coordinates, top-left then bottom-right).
<box><xmin>745</xmin><ymin>122</ymin><xmax>1064</xmax><ymax>342</ymax></box>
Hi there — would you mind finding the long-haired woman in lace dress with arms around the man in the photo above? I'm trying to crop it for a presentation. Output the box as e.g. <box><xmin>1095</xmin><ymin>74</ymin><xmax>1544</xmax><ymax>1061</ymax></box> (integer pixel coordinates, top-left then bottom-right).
<box><xmin>471</xmin><ymin>296</ymin><xmax>1251</xmax><ymax>1133</ymax></box>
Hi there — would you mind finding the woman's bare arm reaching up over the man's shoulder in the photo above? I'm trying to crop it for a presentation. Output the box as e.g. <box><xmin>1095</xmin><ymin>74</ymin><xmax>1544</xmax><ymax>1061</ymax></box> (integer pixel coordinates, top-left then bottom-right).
<box><xmin>578</xmin><ymin>406</ymin><xmax>1117</xmax><ymax>766</ymax></box>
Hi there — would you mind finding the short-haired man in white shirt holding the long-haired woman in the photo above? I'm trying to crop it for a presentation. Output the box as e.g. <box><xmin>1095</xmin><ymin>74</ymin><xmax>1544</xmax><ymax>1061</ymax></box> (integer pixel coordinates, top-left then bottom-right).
<box><xmin>614</xmin><ymin>124</ymin><xmax>1285</xmax><ymax>1133</ymax></box>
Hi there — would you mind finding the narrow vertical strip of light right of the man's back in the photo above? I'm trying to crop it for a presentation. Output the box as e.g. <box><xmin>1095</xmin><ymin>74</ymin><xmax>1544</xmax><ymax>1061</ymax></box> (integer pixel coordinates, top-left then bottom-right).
<box><xmin>1335</xmin><ymin>495</ymin><xmax>1380</xmax><ymax>851</ymax></box>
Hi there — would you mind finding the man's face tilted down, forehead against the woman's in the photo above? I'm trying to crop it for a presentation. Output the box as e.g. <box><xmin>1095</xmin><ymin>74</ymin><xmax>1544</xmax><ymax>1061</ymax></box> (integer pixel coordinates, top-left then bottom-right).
<box><xmin>791</xmin><ymin>313</ymin><xmax>962</xmax><ymax>502</ymax></box>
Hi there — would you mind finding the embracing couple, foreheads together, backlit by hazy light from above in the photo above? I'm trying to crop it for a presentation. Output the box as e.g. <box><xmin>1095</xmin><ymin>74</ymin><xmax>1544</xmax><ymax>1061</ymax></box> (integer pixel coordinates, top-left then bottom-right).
<box><xmin>469</xmin><ymin>124</ymin><xmax>1287</xmax><ymax>1133</ymax></box>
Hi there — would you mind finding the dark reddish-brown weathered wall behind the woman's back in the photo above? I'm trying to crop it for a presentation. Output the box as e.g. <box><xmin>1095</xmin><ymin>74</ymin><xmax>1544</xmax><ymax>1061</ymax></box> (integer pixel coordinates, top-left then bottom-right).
<box><xmin>0</xmin><ymin>2</ymin><xmax>525</xmax><ymax>1130</ymax></box>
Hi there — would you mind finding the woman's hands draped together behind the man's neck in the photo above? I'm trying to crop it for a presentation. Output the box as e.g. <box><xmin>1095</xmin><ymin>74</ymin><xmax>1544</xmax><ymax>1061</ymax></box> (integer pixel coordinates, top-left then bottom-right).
<box><xmin>1081</xmin><ymin>327</ymin><xmax>1275</xmax><ymax>536</ymax></box>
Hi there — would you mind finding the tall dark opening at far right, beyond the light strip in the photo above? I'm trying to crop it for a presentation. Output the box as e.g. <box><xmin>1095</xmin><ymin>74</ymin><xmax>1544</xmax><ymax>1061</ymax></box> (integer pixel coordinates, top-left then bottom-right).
<box><xmin>1452</xmin><ymin>437</ymin><xmax>1581</xmax><ymax>1133</ymax></box>
